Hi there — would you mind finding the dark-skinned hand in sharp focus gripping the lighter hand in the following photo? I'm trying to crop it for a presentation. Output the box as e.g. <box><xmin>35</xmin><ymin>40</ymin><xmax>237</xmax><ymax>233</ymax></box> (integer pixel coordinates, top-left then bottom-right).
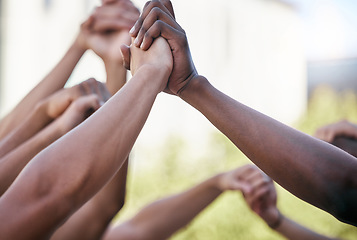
<box><xmin>125</xmin><ymin>0</ymin><xmax>198</xmax><ymax>95</ymax></box>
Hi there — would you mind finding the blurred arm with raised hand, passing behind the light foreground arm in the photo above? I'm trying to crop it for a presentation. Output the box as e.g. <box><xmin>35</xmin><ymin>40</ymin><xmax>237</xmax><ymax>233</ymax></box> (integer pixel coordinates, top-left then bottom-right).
<box><xmin>52</xmin><ymin>0</ymin><xmax>139</xmax><ymax>239</ymax></box>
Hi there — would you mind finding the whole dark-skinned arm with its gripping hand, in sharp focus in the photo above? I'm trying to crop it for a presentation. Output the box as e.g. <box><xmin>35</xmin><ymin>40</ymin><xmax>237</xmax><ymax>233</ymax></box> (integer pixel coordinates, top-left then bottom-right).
<box><xmin>131</xmin><ymin>1</ymin><xmax>357</xmax><ymax>225</ymax></box>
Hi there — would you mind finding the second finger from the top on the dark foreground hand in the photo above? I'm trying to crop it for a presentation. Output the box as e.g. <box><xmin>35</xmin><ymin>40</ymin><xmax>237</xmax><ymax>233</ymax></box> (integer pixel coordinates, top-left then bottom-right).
<box><xmin>135</xmin><ymin>7</ymin><xmax>183</xmax><ymax>47</ymax></box>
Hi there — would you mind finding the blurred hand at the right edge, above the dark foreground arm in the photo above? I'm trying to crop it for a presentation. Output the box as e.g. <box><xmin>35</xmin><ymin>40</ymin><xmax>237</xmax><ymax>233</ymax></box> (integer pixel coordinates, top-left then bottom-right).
<box><xmin>315</xmin><ymin>120</ymin><xmax>357</xmax><ymax>143</ymax></box>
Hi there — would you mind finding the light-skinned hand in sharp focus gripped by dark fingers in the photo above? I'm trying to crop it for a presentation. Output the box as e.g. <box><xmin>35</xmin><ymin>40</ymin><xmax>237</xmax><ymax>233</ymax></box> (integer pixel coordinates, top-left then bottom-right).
<box><xmin>121</xmin><ymin>38</ymin><xmax>172</xmax><ymax>91</ymax></box>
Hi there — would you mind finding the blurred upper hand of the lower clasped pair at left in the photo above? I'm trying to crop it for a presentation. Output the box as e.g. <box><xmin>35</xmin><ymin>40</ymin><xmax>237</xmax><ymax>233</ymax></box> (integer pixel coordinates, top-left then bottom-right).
<box><xmin>40</xmin><ymin>78</ymin><xmax>110</xmax><ymax>119</ymax></box>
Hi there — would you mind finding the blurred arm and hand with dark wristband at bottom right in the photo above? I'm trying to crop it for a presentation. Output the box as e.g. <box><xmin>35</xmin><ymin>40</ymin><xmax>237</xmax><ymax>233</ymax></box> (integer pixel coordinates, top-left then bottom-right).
<box><xmin>241</xmin><ymin>165</ymin><xmax>333</xmax><ymax>240</ymax></box>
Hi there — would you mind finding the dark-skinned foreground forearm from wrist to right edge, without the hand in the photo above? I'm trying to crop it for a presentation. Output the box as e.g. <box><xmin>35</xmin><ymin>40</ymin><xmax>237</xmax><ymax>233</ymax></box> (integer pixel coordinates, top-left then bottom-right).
<box><xmin>181</xmin><ymin>77</ymin><xmax>357</xmax><ymax>223</ymax></box>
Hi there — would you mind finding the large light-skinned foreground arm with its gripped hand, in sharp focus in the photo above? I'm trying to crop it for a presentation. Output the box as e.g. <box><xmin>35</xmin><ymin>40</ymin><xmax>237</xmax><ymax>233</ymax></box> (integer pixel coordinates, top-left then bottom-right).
<box><xmin>0</xmin><ymin>36</ymin><xmax>172</xmax><ymax>239</ymax></box>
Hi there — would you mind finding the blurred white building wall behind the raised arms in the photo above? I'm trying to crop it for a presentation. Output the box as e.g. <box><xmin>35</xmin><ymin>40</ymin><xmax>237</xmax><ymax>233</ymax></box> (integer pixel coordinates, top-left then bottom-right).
<box><xmin>0</xmin><ymin>0</ymin><xmax>306</xmax><ymax>152</ymax></box>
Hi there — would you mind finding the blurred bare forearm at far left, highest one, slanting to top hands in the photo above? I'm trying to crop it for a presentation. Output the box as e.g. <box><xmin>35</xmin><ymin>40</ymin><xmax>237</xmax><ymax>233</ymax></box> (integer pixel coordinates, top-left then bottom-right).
<box><xmin>0</xmin><ymin>42</ymin><xmax>85</xmax><ymax>139</ymax></box>
